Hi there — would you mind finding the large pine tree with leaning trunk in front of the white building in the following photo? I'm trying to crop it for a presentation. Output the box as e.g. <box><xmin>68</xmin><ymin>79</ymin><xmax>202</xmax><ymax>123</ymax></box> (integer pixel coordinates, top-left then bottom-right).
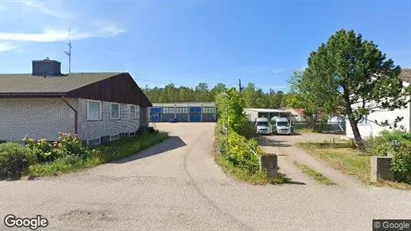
<box><xmin>292</xmin><ymin>30</ymin><xmax>410</xmax><ymax>152</ymax></box>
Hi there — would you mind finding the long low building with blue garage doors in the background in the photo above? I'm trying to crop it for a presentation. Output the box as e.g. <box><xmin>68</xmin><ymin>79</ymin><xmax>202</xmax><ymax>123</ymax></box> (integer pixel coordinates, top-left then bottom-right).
<box><xmin>150</xmin><ymin>102</ymin><xmax>217</xmax><ymax>123</ymax></box>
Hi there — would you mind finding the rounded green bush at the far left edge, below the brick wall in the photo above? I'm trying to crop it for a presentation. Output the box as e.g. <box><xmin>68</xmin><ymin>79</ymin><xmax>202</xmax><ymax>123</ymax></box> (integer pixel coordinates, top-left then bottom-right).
<box><xmin>0</xmin><ymin>143</ymin><xmax>36</xmax><ymax>177</ymax></box>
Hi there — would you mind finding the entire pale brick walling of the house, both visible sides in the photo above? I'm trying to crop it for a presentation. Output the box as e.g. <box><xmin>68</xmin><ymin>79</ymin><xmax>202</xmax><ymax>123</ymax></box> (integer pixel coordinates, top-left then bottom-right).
<box><xmin>0</xmin><ymin>98</ymin><xmax>145</xmax><ymax>141</ymax></box>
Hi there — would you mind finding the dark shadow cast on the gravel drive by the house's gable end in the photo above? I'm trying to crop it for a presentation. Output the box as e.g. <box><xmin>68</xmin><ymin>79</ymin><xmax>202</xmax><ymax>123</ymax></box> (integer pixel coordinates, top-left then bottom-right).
<box><xmin>113</xmin><ymin>136</ymin><xmax>187</xmax><ymax>164</ymax></box>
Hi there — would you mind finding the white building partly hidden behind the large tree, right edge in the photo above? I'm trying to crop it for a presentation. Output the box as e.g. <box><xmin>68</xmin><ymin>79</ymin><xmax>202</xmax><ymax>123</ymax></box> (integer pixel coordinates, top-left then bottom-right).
<box><xmin>346</xmin><ymin>69</ymin><xmax>411</xmax><ymax>138</ymax></box>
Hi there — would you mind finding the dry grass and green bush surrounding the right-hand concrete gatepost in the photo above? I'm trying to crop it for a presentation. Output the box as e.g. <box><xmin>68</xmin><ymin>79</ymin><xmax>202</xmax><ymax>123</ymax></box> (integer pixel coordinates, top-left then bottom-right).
<box><xmin>299</xmin><ymin>131</ymin><xmax>411</xmax><ymax>189</ymax></box>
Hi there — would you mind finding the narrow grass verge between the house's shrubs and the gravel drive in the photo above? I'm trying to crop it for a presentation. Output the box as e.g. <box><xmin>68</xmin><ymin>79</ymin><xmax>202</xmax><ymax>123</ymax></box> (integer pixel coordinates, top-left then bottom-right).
<box><xmin>26</xmin><ymin>132</ymin><xmax>168</xmax><ymax>177</ymax></box>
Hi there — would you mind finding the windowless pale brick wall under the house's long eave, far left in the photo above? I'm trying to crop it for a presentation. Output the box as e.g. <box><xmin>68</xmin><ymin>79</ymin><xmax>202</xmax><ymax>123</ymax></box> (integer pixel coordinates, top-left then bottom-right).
<box><xmin>0</xmin><ymin>98</ymin><xmax>76</xmax><ymax>141</ymax></box>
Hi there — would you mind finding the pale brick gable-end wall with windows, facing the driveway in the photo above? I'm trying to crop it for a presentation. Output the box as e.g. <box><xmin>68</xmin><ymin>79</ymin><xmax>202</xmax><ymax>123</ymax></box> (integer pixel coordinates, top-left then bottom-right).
<box><xmin>78</xmin><ymin>99</ymin><xmax>140</xmax><ymax>140</ymax></box>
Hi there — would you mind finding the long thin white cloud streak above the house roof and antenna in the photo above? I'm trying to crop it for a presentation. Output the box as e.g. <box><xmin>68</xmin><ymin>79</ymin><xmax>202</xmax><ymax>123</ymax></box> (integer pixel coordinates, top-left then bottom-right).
<box><xmin>0</xmin><ymin>24</ymin><xmax>125</xmax><ymax>42</ymax></box>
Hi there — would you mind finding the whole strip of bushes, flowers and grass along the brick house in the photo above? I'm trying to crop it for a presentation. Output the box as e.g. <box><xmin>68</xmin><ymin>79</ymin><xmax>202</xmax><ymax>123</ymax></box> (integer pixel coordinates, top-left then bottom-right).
<box><xmin>0</xmin><ymin>131</ymin><xmax>168</xmax><ymax>178</ymax></box>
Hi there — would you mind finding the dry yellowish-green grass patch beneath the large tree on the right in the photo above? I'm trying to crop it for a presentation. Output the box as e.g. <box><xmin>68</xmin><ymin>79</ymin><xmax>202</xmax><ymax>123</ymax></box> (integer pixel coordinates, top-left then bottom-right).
<box><xmin>298</xmin><ymin>143</ymin><xmax>411</xmax><ymax>190</ymax></box>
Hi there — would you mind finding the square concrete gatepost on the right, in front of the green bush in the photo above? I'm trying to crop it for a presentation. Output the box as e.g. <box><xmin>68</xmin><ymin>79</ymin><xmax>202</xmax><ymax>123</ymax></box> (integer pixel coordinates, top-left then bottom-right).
<box><xmin>371</xmin><ymin>156</ymin><xmax>394</xmax><ymax>182</ymax></box>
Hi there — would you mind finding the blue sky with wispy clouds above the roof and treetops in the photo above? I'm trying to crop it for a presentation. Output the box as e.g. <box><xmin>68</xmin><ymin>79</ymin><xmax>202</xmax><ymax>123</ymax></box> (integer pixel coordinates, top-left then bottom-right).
<box><xmin>0</xmin><ymin>0</ymin><xmax>411</xmax><ymax>90</ymax></box>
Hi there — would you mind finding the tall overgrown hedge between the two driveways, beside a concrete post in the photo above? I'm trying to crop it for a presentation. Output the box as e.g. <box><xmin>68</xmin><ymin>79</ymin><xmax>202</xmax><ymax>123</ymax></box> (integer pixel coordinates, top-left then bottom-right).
<box><xmin>215</xmin><ymin>88</ymin><xmax>288</xmax><ymax>184</ymax></box>
